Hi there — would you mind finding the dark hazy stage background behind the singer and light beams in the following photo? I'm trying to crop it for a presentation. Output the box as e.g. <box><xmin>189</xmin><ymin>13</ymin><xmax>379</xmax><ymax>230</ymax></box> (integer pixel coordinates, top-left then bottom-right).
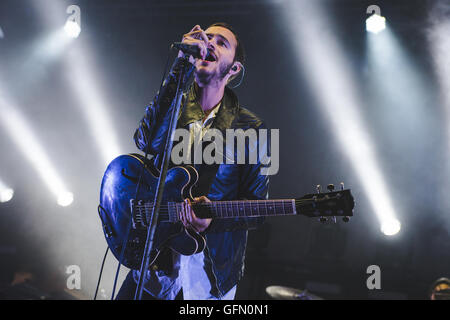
<box><xmin>0</xmin><ymin>0</ymin><xmax>450</xmax><ymax>299</ymax></box>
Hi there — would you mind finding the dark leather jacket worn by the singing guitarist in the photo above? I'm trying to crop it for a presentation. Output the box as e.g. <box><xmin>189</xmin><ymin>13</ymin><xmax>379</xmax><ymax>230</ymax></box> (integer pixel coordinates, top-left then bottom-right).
<box><xmin>134</xmin><ymin>58</ymin><xmax>269</xmax><ymax>296</ymax></box>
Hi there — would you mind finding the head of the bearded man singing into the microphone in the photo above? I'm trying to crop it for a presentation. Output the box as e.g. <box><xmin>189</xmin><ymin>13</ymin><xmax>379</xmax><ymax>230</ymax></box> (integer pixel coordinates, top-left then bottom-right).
<box><xmin>192</xmin><ymin>22</ymin><xmax>245</xmax><ymax>87</ymax></box>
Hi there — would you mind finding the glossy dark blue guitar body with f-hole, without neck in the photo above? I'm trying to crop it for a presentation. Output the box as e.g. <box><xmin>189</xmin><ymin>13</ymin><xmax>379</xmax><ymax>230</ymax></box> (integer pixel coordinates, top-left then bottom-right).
<box><xmin>99</xmin><ymin>154</ymin><xmax>206</xmax><ymax>269</ymax></box>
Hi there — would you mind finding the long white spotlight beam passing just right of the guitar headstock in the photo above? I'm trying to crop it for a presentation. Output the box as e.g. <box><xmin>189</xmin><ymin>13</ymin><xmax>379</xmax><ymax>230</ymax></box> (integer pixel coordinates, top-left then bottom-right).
<box><xmin>283</xmin><ymin>1</ymin><xmax>400</xmax><ymax>234</ymax></box>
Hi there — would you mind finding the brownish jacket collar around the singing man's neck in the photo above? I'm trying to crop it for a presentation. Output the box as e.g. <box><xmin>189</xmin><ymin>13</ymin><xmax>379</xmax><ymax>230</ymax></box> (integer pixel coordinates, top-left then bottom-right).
<box><xmin>178</xmin><ymin>84</ymin><xmax>239</xmax><ymax>132</ymax></box>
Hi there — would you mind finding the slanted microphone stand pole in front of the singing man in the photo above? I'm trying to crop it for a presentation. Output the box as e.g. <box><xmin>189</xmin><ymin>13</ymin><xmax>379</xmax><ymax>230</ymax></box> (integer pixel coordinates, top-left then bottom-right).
<box><xmin>134</xmin><ymin>55</ymin><xmax>189</xmax><ymax>300</ymax></box>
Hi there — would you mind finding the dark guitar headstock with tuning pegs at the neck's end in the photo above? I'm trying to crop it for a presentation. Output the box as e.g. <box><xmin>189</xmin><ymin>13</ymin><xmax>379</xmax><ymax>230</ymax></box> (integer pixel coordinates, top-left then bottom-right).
<box><xmin>295</xmin><ymin>183</ymin><xmax>355</xmax><ymax>222</ymax></box>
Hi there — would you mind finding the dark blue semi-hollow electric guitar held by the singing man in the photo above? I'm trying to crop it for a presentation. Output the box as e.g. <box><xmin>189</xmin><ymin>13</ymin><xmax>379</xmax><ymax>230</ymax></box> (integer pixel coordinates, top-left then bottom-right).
<box><xmin>99</xmin><ymin>154</ymin><xmax>354</xmax><ymax>269</ymax></box>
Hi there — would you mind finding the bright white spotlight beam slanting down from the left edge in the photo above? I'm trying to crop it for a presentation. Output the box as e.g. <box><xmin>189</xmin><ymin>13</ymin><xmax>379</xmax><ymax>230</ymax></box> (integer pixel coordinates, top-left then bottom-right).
<box><xmin>0</xmin><ymin>88</ymin><xmax>73</xmax><ymax>206</ymax></box>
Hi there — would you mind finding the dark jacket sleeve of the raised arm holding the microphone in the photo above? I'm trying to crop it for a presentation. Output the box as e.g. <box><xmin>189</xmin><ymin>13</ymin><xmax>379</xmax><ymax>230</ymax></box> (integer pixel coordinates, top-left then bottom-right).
<box><xmin>134</xmin><ymin>57</ymin><xmax>195</xmax><ymax>156</ymax></box>
